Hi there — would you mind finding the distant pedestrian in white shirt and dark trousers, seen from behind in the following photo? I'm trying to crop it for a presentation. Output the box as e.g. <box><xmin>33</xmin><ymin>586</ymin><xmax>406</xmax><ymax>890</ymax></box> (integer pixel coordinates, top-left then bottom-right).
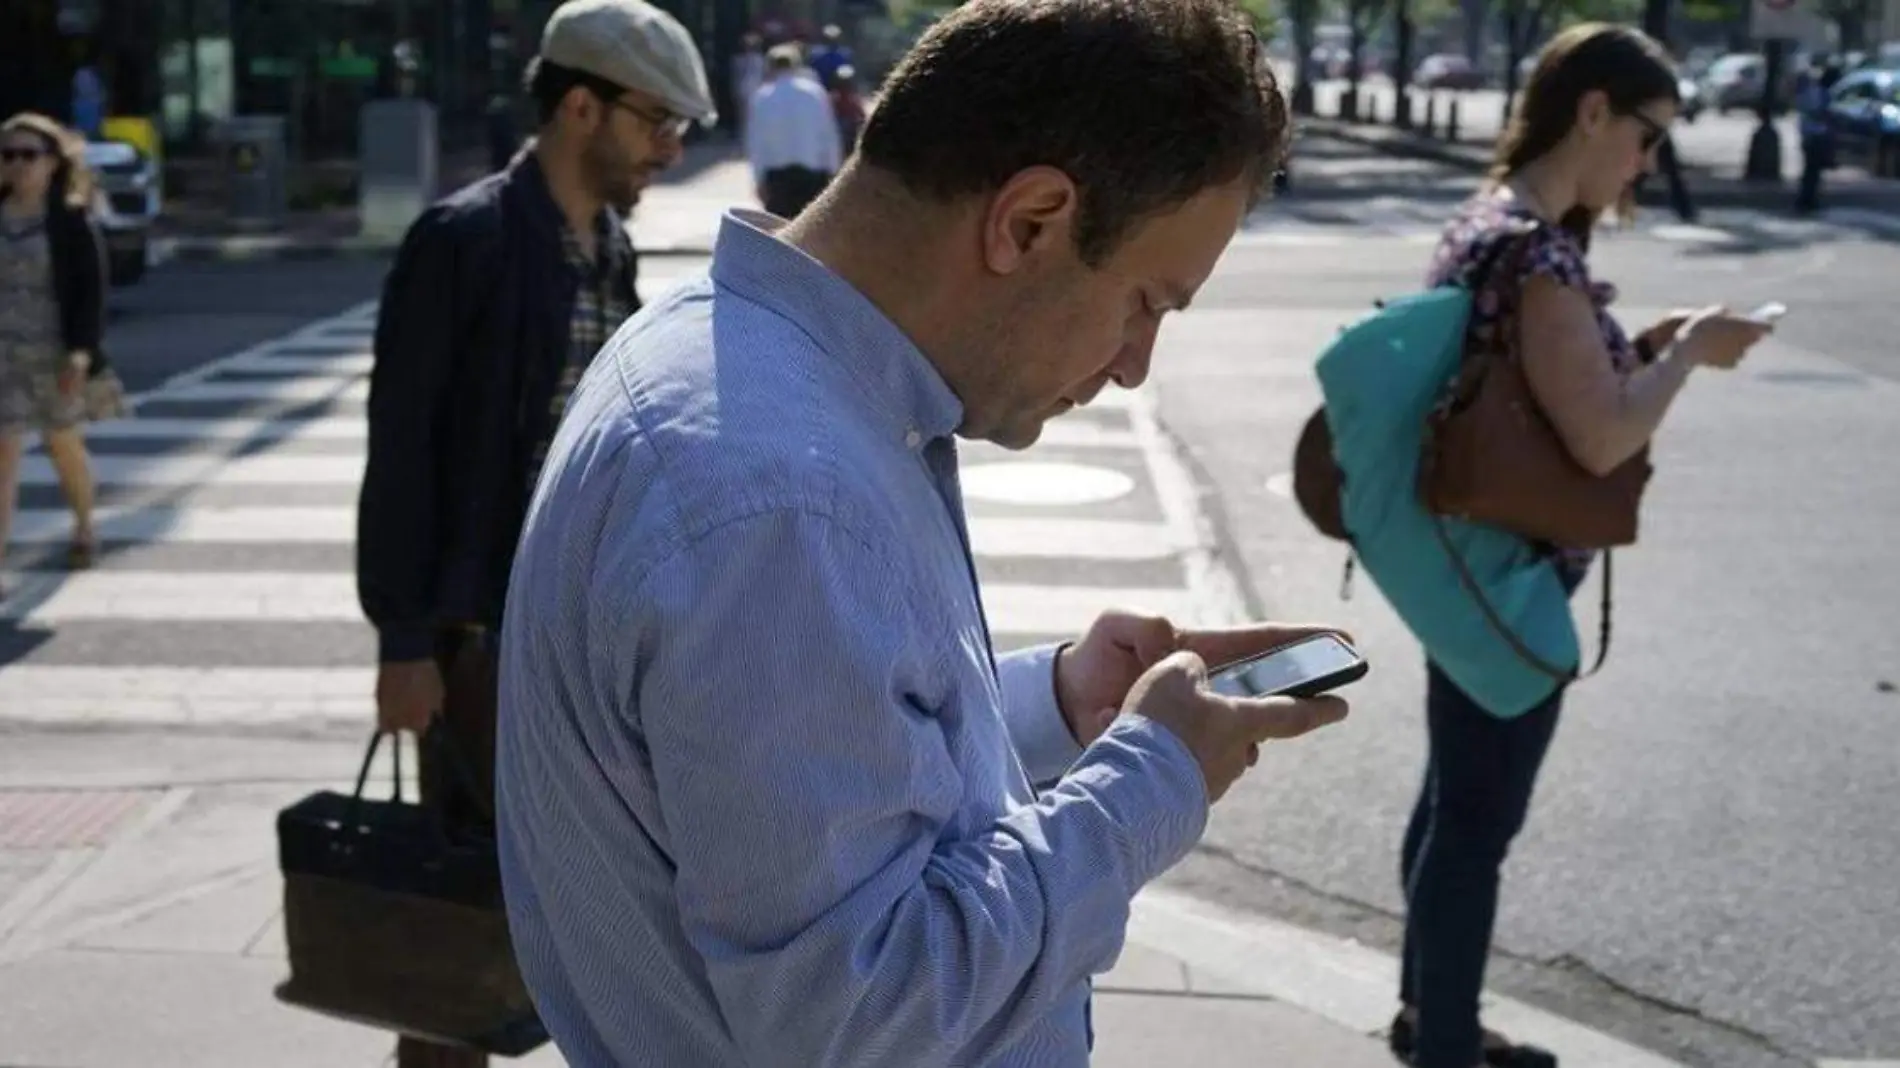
<box><xmin>745</xmin><ymin>46</ymin><xmax>844</xmax><ymax>219</ymax></box>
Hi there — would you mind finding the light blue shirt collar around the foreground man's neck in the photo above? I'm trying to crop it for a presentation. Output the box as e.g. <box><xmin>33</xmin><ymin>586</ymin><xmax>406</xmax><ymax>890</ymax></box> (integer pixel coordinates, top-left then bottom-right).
<box><xmin>713</xmin><ymin>209</ymin><xmax>963</xmax><ymax>448</ymax></box>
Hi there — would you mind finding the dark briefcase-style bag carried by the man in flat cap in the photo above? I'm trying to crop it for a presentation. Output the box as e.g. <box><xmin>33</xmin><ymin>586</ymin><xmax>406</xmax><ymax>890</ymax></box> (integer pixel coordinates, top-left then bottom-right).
<box><xmin>276</xmin><ymin>726</ymin><xmax>547</xmax><ymax>1057</ymax></box>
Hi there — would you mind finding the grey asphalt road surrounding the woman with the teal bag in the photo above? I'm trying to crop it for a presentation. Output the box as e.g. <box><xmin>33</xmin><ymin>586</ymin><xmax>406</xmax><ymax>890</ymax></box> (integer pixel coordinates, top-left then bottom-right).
<box><xmin>1155</xmin><ymin>145</ymin><xmax>1900</xmax><ymax>1068</ymax></box>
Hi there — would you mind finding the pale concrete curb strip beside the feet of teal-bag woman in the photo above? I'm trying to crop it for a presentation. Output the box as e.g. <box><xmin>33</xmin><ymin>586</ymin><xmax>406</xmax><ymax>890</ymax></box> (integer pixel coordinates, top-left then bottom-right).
<box><xmin>1129</xmin><ymin>887</ymin><xmax>1685</xmax><ymax>1068</ymax></box>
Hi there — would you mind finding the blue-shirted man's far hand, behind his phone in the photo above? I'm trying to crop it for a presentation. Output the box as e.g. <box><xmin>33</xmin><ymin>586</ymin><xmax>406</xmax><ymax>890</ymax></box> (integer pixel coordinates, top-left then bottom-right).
<box><xmin>1055</xmin><ymin>612</ymin><xmax>1347</xmax><ymax>747</ymax></box>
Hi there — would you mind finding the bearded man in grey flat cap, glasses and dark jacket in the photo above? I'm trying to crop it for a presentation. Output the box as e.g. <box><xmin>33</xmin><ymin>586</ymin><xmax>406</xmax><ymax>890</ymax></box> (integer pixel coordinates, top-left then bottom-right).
<box><xmin>357</xmin><ymin>0</ymin><xmax>716</xmax><ymax>1068</ymax></box>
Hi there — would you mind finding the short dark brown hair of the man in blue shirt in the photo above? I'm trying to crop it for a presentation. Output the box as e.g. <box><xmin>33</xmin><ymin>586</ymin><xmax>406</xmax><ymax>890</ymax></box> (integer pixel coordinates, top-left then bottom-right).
<box><xmin>859</xmin><ymin>0</ymin><xmax>1288</xmax><ymax>264</ymax></box>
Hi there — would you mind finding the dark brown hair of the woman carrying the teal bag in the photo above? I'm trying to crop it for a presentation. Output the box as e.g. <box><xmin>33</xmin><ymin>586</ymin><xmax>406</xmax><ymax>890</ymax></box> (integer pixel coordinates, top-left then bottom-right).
<box><xmin>1490</xmin><ymin>23</ymin><xmax>1682</xmax><ymax>247</ymax></box>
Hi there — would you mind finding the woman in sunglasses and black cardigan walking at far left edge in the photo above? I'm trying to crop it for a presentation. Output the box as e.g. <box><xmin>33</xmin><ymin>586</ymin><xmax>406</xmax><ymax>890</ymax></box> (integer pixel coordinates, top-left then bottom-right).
<box><xmin>0</xmin><ymin>112</ymin><xmax>116</xmax><ymax>595</ymax></box>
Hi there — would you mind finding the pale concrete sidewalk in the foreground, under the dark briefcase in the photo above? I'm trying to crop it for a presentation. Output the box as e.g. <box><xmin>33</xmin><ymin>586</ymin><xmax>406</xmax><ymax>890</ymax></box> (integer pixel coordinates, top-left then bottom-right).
<box><xmin>0</xmin><ymin>734</ymin><xmax>1393</xmax><ymax>1068</ymax></box>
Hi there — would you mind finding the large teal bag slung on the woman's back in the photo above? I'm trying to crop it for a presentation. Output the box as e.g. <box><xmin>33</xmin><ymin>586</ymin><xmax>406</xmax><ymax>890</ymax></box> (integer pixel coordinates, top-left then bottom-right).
<box><xmin>1294</xmin><ymin>252</ymin><xmax>1609</xmax><ymax>718</ymax></box>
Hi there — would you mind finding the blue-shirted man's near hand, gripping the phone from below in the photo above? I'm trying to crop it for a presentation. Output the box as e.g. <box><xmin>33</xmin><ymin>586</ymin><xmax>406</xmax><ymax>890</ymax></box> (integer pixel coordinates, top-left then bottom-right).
<box><xmin>1123</xmin><ymin>652</ymin><xmax>1347</xmax><ymax>802</ymax></box>
